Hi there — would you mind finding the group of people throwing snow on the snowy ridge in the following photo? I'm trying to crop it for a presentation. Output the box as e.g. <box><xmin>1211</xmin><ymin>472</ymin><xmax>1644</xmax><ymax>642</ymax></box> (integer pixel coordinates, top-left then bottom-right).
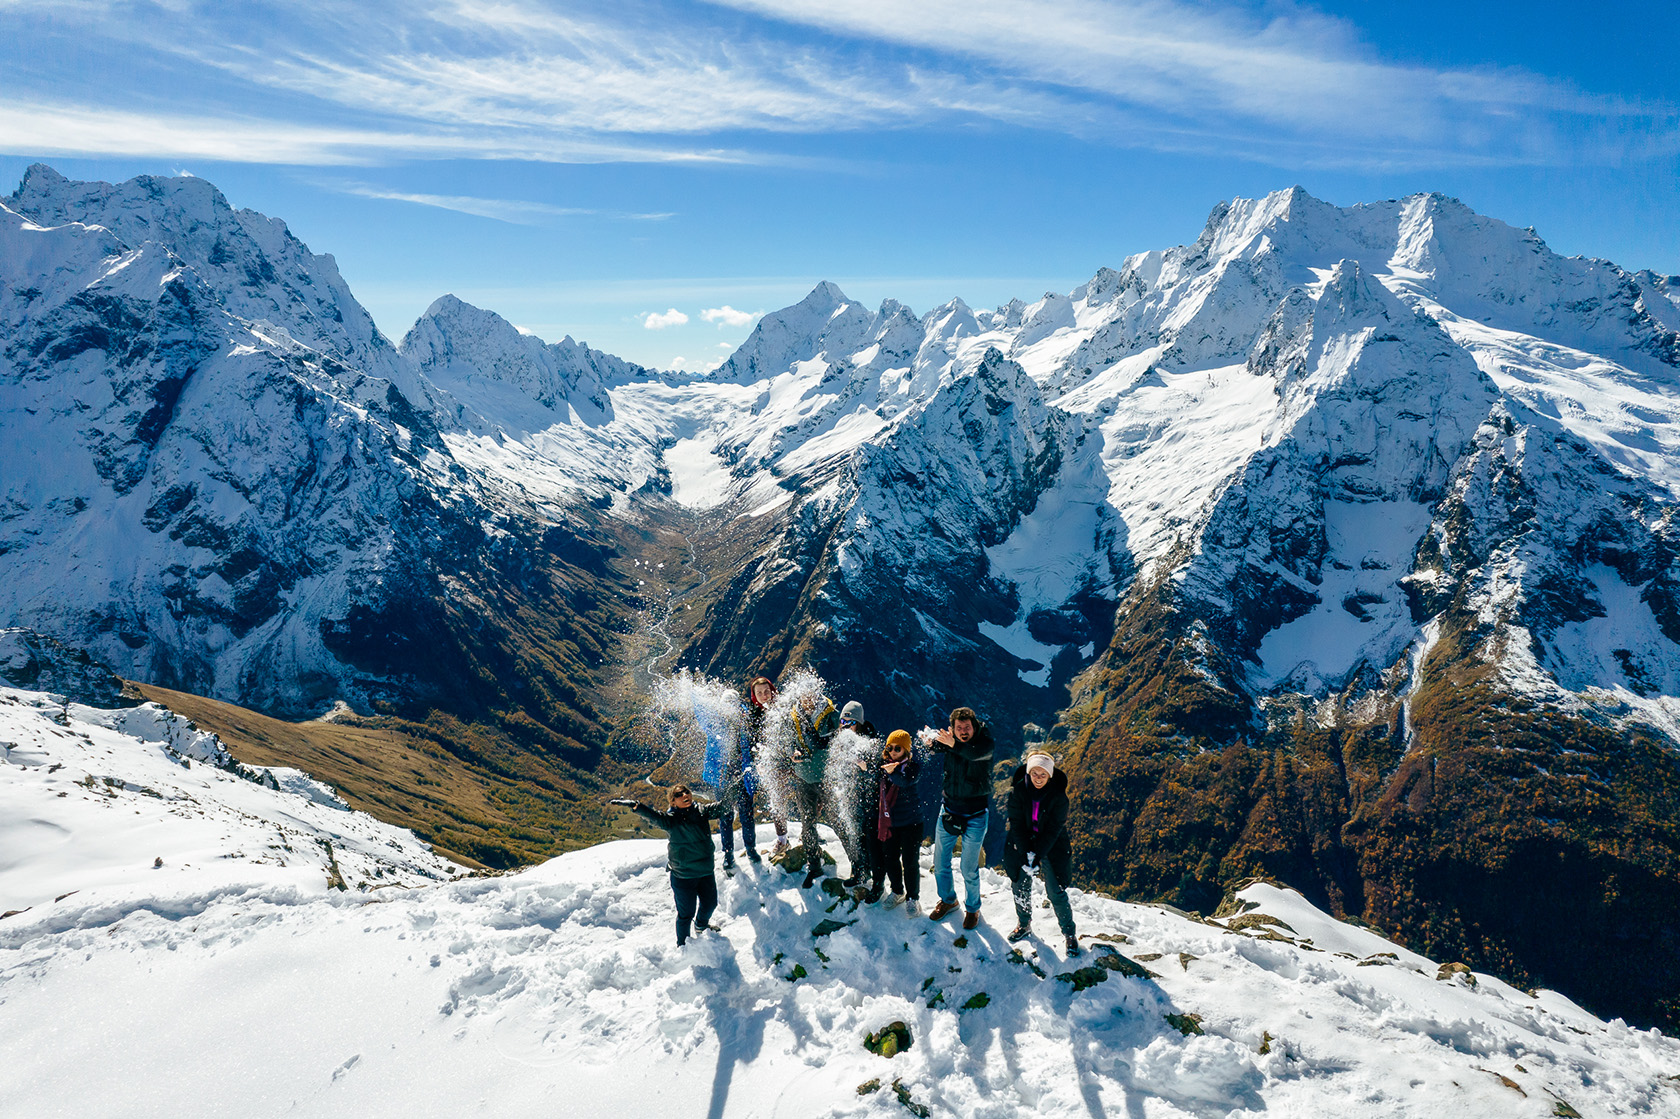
<box><xmin>612</xmin><ymin>665</ymin><xmax>1080</xmax><ymax>956</ymax></box>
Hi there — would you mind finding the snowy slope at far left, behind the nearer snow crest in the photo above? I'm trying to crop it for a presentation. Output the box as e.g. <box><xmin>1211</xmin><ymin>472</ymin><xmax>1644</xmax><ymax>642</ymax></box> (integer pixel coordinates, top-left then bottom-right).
<box><xmin>0</xmin><ymin>687</ymin><xmax>462</xmax><ymax>934</ymax></box>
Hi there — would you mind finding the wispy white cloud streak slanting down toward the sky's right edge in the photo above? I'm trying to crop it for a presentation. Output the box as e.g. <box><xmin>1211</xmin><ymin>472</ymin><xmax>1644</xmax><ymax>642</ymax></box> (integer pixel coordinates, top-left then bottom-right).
<box><xmin>717</xmin><ymin>0</ymin><xmax>1680</xmax><ymax>163</ymax></box>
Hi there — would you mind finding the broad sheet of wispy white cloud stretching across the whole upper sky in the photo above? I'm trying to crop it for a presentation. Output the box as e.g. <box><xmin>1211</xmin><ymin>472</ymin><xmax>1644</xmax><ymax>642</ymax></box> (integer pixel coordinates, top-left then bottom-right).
<box><xmin>0</xmin><ymin>0</ymin><xmax>1680</xmax><ymax>169</ymax></box>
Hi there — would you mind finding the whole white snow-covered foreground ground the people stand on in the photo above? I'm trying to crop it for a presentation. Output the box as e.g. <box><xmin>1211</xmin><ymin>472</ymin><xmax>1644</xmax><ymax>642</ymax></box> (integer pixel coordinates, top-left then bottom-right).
<box><xmin>0</xmin><ymin>689</ymin><xmax>1680</xmax><ymax>1119</ymax></box>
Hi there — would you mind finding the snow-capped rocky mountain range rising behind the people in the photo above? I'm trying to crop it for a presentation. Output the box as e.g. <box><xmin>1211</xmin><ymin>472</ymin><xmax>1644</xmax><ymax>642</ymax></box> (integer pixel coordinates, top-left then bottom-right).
<box><xmin>0</xmin><ymin>168</ymin><xmax>1680</xmax><ymax>1025</ymax></box>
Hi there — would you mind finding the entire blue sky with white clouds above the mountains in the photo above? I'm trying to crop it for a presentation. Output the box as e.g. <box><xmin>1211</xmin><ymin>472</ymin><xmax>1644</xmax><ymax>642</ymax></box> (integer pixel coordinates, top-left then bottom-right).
<box><xmin>0</xmin><ymin>0</ymin><xmax>1680</xmax><ymax>368</ymax></box>
